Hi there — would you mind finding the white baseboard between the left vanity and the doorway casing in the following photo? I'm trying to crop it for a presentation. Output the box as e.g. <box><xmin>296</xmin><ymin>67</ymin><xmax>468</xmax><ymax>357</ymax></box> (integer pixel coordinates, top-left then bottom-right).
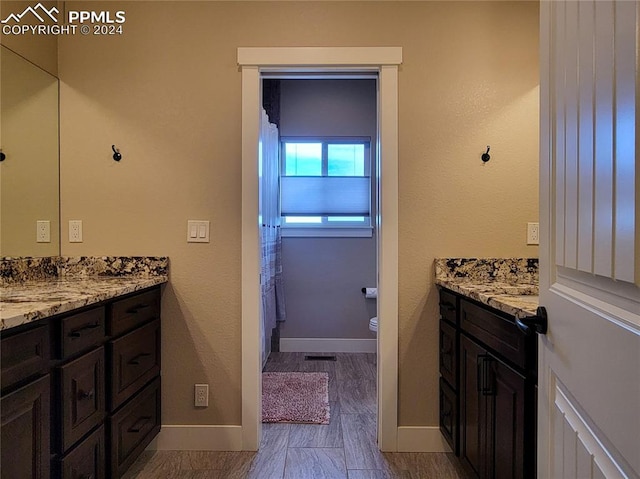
<box><xmin>147</xmin><ymin>424</ymin><xmax>242</xmax><ymax>451</ymax></box>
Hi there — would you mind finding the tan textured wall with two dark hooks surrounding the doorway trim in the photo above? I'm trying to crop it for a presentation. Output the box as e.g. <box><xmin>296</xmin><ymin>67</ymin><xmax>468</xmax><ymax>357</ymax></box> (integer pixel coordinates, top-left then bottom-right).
<box><xmin>59</xmin><ymin>2</ymin><xmax>538</xmax><ymax>425</ymax></box>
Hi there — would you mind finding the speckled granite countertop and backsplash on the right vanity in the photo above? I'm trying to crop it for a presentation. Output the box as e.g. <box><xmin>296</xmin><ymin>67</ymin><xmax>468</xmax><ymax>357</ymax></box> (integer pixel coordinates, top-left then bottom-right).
<box><xmin>435</xmin><ymin>258</ymin><xmax>539</xmax><ymax>316</ymax></box>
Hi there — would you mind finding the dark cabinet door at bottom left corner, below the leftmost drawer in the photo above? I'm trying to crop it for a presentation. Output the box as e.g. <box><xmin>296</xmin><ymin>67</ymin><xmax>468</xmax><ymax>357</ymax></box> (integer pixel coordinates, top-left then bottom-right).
<box><xmin>0</xmin><ymin>374</ymin><xmax>51</xmax><ymax>479</ymax></box>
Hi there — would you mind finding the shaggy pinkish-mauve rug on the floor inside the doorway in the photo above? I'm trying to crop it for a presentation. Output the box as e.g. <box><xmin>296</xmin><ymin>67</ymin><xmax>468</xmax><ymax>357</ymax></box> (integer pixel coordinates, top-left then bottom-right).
<box><xmin>262</xmin><ymin>373</ymin><xmax>330</xmax><ymax>424</ymax></box>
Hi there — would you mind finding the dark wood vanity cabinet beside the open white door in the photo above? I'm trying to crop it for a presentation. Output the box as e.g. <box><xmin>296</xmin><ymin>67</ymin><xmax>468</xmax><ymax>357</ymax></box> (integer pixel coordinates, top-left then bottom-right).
<box><xmin>440</xmin><ymin>290</ymin><xmax>537</xmax><ymax>479</ymax></box>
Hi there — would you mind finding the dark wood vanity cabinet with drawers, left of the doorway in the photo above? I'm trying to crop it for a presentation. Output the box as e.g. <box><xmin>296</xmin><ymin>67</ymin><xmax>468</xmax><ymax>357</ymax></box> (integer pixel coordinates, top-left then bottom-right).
<box><xmin>0</xmin><ymin>286</ymin><xmax>161</xmax><ymax>479</ymax></box>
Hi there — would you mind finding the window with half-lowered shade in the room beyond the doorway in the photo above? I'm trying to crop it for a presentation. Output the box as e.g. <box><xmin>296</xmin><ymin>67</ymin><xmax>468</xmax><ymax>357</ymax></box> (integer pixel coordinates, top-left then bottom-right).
<box><xmin>280</xmin><ymin>138</ymin><xmax>371</xmax><ymax>235</ymax></box>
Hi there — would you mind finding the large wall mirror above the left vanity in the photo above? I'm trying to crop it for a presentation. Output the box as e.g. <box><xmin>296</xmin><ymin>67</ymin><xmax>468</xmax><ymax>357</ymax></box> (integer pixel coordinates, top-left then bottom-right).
<box><xmin>0</xmin><ymin>45</ymin><xmax>60</xmax><ymax>257</ymax></box>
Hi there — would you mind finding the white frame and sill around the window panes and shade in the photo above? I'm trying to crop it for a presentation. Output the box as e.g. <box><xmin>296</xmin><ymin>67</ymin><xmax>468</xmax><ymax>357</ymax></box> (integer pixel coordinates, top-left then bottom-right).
<box><xmin>278</xmin><ymin>136</ymin><xmax>375</xmax><ymax>238</ymax></box>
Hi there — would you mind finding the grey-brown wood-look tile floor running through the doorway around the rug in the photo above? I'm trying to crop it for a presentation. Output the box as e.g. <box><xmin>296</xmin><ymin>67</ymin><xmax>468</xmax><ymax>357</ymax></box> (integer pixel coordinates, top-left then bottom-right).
<box><xmin>125</xmin><ymin>353</ymin><xmax>467</xmax><ymax>479</ymax></box>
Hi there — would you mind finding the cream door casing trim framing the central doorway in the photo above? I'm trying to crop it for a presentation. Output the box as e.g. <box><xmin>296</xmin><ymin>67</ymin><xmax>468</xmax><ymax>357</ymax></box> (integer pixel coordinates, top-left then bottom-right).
<box><xmin>238</xmin><ymin>47</ymin><xmax>402</xmax><ymax>451</ymax></box>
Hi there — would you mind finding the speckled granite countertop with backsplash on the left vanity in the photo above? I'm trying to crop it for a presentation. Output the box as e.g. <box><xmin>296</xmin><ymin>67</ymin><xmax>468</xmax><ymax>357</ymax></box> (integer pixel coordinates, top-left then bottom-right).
<box><xmin>0</xmin><ymin>256</ymin><xmax>169</xmax><ymax>331</ymax></box>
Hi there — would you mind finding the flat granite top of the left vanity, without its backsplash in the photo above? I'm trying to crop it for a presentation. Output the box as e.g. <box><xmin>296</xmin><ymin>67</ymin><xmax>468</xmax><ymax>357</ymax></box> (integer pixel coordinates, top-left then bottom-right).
<box><xmin>0</xmin><ymin>275</ymin><xmax>169</xmax><ymax>331</ymax></box>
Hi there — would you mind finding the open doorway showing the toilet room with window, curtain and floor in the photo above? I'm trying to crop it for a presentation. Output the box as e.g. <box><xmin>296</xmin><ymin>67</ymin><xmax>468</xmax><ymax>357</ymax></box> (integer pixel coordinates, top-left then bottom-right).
<box><xmin>258</xmin><ymin>72</ymin><xmax>378</xmax><ymax>448</ymax></box>
